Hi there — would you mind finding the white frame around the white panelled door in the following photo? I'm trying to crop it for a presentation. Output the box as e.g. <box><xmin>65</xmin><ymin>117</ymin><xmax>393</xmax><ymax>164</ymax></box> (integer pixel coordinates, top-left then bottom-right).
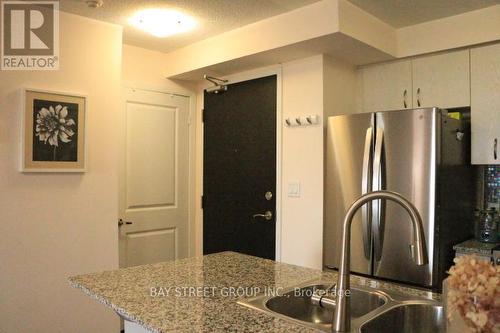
<box><xmin>118</xmin><ymin>84</ymin><xmax>196</xmax><ymax>257</ymax></box>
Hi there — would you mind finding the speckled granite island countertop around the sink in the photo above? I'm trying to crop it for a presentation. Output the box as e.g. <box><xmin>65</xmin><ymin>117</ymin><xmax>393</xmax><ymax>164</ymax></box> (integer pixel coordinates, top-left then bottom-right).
<box><xmin>69</xmin><ymin>252</ymin><xmax>440</xmax><ymax>333</ymax></box>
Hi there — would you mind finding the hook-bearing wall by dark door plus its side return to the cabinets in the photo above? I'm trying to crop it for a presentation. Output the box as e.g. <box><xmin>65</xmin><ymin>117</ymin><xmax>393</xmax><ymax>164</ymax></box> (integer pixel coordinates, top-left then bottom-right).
<box><xmin>281</xmin><ymin>55</ymin><xmax>357</xmax><ymax>269</ymax></box>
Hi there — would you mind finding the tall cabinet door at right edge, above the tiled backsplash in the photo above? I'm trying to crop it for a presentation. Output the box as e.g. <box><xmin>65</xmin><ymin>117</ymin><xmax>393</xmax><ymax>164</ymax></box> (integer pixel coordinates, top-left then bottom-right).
<box><xmin>471</xmin><ymin>44</ymin><xmax>500</xmax><ymax>164</ymax></box>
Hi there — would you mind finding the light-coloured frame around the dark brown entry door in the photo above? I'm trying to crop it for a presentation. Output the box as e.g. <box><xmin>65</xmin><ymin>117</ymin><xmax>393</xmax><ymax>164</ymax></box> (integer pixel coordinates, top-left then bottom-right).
<box><xmin>201</xmin><ymin>65</ymin><xmax>283</xmax><ymax>262</ymax></box>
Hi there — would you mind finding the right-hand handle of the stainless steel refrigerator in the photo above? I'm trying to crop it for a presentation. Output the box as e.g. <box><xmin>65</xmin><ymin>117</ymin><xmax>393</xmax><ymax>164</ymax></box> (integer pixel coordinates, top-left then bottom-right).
<box><xmin>372</xmin><ymin>128</ymin><xmax>386</xmax><ymax>261</ymax></box>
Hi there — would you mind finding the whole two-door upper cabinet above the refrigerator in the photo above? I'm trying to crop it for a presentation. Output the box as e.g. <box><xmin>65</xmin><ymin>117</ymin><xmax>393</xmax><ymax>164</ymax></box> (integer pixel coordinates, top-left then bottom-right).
<box><xmin>360</xmin><ymin>50</ymin><xmax>470</xmax><ymax>112</ymax></box>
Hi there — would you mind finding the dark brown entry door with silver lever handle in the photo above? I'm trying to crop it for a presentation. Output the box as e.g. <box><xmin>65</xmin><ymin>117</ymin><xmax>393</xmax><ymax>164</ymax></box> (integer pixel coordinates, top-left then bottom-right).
<box><xmin>203</xmin><ymin>75</ymin><xmax>276</xmax><ymax>259</ymax></box>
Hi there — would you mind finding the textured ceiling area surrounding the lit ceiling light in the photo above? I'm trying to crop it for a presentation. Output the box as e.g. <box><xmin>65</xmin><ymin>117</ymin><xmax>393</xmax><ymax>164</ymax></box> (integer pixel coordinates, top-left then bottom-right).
<box><xmin>60</xmin><ymin>0</ymin><xmax>318</xmax><ymax>52</ymax></box>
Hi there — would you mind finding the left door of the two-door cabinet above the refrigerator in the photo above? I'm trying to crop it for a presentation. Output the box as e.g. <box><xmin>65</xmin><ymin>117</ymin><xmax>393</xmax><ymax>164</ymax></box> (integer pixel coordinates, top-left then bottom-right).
<box><xmin>361</xmin><ymin>60</ymin><xmax>412</xmax><ymax>112</ymax></box>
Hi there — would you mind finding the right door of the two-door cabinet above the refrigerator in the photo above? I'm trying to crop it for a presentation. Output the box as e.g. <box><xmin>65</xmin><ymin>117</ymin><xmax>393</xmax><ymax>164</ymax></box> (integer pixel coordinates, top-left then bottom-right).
<box><xmin>412</xmin><ymin>50</ymin><xmax>470</xmax><ymax>108</ymax></box>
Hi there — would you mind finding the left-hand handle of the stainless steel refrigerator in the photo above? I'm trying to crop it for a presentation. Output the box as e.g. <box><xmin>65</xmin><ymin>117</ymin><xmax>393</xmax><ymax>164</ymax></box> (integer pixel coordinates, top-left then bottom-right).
<box><xmin>361</xmin><ymin>127</ymin><xmax>373</xmax><ymax>260</ymax></box>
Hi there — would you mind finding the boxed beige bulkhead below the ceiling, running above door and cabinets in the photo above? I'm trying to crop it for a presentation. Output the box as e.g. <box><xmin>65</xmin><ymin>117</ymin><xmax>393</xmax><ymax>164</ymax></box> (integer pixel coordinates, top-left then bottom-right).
<box><xmin>162</xmin><ymin>0</ymin><xmax>500</xmax><ymax>80</ymax></box>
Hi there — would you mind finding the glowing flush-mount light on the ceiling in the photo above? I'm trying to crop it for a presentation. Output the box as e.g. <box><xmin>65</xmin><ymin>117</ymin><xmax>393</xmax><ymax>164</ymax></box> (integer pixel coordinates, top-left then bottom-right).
<box><xmin>129</xmin><ymin>9</ymin><xmax>196</xmax><ymax>37</ymax></box>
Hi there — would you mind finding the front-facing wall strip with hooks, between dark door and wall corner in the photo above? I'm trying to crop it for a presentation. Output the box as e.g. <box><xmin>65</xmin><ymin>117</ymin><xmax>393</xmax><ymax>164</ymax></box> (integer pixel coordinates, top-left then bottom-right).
<box><xmin>281</xmin><ymin>55</ymin><xmax>324</xmax><ymax>268</ymax></box>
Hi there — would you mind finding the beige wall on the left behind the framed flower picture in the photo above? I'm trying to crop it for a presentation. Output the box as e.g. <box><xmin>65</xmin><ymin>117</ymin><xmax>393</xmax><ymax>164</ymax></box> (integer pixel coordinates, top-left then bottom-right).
<box><xmin>0</xmin><ymin>13</ymin><xmax>122</xmax><ymax>333</ymax></box>
